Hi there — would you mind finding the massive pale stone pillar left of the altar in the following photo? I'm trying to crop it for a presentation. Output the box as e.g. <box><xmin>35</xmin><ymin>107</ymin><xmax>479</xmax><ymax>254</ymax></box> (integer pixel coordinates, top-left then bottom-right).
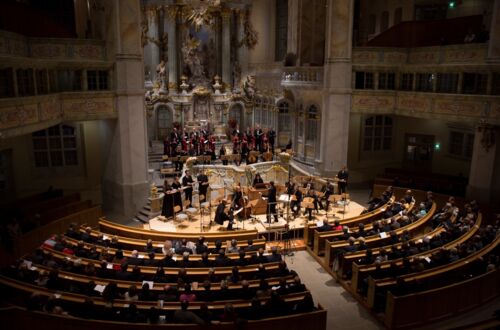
<box><xmin>103</xmin><ymin>0</ymin><xmax>148</xmax><ymax>220</ymax></box>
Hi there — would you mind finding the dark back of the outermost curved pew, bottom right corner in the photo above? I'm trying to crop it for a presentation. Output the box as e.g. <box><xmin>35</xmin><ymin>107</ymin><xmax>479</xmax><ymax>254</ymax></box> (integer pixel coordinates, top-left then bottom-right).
<box><xmin>385</xmin><ymin>269</ymin><xmax>500</xmax><ymax>329</ymax></box>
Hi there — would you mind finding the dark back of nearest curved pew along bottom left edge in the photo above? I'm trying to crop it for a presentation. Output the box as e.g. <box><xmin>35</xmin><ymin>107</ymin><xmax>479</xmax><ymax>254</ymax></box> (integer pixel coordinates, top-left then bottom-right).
<box><xmin>0</xmin><ymin>305</ymin><xmax>326</xmax><ymax>330</ymax></box>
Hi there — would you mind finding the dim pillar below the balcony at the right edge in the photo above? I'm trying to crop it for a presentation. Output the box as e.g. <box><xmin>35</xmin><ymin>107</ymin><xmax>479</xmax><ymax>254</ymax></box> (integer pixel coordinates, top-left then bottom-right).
<box><xmin>467</xmin><ymin>125</ymin><xmax>500</xmax><ymax>203</ymax></box>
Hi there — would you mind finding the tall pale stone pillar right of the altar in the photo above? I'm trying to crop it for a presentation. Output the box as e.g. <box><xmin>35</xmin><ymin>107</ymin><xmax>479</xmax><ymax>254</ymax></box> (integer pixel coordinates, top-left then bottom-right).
<box><xmin>316</xmin><ymin>0</ymin><xmax>354</xmax><ymax>175</ymax></box>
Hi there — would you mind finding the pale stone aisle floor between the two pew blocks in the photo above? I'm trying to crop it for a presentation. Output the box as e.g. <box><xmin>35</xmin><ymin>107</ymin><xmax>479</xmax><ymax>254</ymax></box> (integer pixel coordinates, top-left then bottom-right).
<box><xmin>286</xmin><ymin>251</ymin><xmax>383</xmax><ymax>329</ymax></box>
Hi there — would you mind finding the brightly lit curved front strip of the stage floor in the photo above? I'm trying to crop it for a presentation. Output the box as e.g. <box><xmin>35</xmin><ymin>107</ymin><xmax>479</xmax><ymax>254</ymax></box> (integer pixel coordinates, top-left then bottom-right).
<box><xmin>144</xmin><ymin>201</ymin><xmax>364</xmax><ymax>235</ymax></box>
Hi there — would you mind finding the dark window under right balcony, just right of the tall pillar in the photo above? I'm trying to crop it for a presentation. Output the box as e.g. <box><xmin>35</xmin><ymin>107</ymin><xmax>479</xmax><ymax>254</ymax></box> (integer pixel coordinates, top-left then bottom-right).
<box><xmin>363</xmin><ymin>116</ymin><xmax>392</xmax><ymax>151</ymax></box>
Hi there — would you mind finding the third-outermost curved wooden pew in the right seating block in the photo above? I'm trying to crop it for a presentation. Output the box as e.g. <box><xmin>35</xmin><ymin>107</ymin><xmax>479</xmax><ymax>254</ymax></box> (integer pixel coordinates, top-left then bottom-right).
<box><xmin>351</xmin><ymin>214</ymin><xmax>482</xmax><ymax>292</ymax></box>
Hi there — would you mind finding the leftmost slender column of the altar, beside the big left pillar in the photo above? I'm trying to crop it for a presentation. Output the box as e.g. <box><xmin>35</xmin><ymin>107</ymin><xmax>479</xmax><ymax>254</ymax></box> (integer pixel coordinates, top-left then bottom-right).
<box><xmin>144</xmin><ymin>7</ymin><xmax>160</xmax><ymax>82</ymax></box>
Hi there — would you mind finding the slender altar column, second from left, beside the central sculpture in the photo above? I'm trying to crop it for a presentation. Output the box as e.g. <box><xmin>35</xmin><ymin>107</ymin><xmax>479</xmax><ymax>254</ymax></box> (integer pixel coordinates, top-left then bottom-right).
<box><xmin>164</xmin><ymin>6</ymin><xmax>179</xmax><ymax>90</ymax></box>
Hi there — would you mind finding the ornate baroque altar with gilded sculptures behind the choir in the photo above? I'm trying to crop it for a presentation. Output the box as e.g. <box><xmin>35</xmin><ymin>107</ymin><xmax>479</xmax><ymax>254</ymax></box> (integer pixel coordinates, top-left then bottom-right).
<box><xmin>142</xmin><ymin>0</ymin><xmax>257</xmax><ymax>140</ymax></box>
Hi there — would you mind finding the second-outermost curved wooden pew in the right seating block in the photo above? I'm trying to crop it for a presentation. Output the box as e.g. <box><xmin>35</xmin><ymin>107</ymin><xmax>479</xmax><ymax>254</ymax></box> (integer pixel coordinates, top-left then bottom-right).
<box><xmin>367</xmin><ymin>236</ymin><xmax>500</xmax><ymax>308</ymax></box>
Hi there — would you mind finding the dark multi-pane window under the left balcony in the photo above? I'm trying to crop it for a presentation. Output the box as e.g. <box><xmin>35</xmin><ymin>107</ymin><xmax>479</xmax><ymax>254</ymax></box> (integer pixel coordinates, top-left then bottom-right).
<box><xmin>32</xmin><ymin>124</ymin><xmax>78</xmax><ymax>167</ymax></box>
